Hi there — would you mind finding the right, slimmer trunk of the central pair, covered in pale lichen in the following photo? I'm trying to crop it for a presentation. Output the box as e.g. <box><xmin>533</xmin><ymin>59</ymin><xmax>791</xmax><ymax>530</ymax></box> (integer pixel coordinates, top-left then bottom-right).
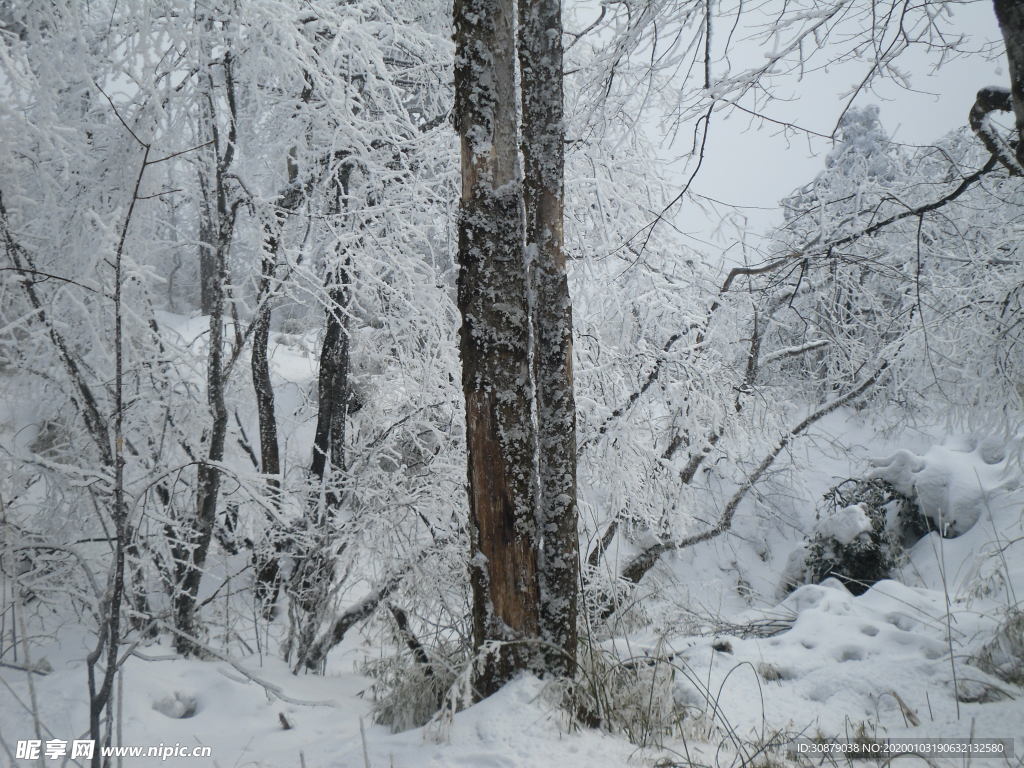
<box><xmin>519</xmin><ymin>0</ymin><xmax>580</xmax><ymax>677</ymax></box>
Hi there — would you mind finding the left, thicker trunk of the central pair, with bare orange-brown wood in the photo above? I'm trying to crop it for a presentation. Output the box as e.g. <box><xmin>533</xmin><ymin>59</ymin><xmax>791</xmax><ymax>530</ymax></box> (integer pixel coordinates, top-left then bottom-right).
<box><xmin>455</xmin><ymin>0</ymin><xmax>540</xmax><ymax>696</ymax></box>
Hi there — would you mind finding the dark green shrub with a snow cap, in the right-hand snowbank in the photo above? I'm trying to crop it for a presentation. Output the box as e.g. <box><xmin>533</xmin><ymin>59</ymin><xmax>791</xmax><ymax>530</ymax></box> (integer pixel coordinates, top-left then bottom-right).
<box><xmin>783</xmin><ymin>479</ymin><xmax>925</xmax><ymax>595</ymax></box>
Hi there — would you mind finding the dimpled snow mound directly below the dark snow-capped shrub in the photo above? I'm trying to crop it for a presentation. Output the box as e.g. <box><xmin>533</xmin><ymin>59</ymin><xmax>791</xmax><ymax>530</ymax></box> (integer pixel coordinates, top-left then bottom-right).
<box><xmin>655</xmin><ymin>579</ymin><xmax>1024</xmax><ymax>738</ymax></box>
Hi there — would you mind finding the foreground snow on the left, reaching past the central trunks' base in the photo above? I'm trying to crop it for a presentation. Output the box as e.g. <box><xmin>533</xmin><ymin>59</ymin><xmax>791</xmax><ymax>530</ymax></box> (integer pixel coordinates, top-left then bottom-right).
<box><xmin>0</xmin><ymin>637</ymin><xmax>671</xmax><ymax>768</ymax></box>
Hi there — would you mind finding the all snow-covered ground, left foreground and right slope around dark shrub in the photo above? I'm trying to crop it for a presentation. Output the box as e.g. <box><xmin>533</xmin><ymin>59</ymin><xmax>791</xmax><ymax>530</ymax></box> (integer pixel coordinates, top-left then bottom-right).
<box><xmin>0</xmin><ymin>415</ymin><xmax>1024</xmax><ymax>768</ymax></box>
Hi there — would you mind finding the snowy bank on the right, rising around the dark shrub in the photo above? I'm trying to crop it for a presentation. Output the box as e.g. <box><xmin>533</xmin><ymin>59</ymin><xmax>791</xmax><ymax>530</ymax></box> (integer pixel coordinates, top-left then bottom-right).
<box><xmin>606</xmin><ymin>419</ymin><xmax>1024</xmax><ymax>757</ymax></box>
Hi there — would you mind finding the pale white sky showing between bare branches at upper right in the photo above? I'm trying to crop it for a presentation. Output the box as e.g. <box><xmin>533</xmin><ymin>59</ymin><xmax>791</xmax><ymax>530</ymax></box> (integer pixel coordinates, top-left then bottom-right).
<box><xmin>647</xmin><ymin>0</ymin><xmax>1008</xmax><ymax>258</ymax></box>
